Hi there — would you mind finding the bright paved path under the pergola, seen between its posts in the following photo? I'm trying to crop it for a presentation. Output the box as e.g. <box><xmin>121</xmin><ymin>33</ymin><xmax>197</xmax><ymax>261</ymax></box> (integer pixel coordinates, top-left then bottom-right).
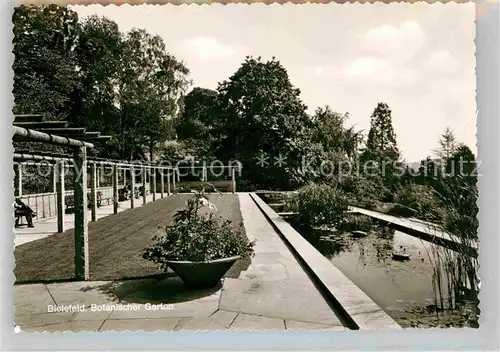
<box><xmin>14</xmin><ymin>193</ymin><xmax>167</xmax><ymax>247</ymax></box>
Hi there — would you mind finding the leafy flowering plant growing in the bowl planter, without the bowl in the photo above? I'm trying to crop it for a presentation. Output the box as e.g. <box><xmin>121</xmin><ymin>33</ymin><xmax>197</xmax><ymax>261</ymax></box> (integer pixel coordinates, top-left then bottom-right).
<box><xmin>143</xmin><ymin>191</ymin><xmax>254</xmax><ymax>270</ymax></box>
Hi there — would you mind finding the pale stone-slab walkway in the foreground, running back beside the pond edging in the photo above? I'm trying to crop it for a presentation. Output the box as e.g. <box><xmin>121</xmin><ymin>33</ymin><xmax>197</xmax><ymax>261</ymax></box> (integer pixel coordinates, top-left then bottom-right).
<box><xmin>15</xmin><ymin>193</ymin><xmax>345</xmax><ymax>332</ymax></box>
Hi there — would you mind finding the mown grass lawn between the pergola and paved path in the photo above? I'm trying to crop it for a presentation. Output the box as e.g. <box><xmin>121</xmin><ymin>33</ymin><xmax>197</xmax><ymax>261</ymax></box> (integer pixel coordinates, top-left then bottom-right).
<box><xmin>14</xmin><ymin>194</ymin><xmax>249</xmax><ymax>283</ymax></box>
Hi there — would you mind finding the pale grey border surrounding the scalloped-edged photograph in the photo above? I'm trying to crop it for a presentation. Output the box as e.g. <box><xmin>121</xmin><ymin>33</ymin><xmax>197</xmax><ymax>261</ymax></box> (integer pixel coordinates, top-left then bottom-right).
<box><xmin>0</xmin><ymin>0</ymin><xmax>500</xmax><ymax>351</ymax></box>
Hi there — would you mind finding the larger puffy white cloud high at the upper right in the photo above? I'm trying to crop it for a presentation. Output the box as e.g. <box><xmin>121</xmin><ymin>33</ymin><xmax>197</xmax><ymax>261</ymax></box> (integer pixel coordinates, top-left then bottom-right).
<box><xmin>360</xmin><ymin>21</ymin><xmax>427</xmax><ymax>60</ymax></box>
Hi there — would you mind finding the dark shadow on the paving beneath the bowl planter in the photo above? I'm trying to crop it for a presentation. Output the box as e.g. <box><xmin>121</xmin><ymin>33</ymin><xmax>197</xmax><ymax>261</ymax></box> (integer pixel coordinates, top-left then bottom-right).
<box><xmin>81</xmin><ymin>275</ymin><xmax>222</xmax><ymax>304</ymax></box>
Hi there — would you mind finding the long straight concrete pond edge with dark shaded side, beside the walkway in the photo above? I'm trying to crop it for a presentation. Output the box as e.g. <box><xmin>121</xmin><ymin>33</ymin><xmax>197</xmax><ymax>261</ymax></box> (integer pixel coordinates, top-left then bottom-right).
<box><xmin>250</xmin><ymin>193</ymin><xmax>401</xmax><ymax>330</ymax></box>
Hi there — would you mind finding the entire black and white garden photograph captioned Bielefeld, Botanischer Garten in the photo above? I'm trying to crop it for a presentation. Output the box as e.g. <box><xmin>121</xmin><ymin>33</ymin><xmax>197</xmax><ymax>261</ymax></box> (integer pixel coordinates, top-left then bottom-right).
<box><xmin>12</xmin><ymin>2</ymin><xmax>481</xmax><ymax>334</ymax></box>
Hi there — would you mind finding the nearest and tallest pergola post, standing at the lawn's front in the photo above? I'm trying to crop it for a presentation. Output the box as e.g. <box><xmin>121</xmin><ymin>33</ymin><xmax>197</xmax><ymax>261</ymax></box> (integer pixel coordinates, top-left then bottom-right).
<box><xmin>73</xmin><ymin>147</ymin><xmax>90</xmax><ymax>280</ymax></box>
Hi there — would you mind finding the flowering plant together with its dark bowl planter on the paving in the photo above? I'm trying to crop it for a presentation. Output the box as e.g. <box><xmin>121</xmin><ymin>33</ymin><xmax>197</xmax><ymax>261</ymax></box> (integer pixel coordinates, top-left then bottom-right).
<box><xmin>143</xmin><ymin>184</ymin><xmax>254</xmax><ymax>288</ymax></box>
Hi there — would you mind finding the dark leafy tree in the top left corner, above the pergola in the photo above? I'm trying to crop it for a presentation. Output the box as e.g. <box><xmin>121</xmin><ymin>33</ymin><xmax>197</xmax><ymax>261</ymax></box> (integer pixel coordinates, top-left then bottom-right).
<box><xmin>12</xmin><ymin>5</ymin><xmax>79</xmax><ymax>120</ymax></box>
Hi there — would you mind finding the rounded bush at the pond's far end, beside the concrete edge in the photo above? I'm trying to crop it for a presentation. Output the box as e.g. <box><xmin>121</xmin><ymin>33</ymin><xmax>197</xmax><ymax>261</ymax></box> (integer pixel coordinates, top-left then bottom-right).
<box><xmin>288</xmin><ymin>183</ymin><xmax>349</xmax><ymax>228</ymax></box>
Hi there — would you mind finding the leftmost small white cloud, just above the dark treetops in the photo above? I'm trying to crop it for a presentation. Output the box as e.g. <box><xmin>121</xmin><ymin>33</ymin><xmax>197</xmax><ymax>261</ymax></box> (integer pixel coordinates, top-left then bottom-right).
<box><xmin>184</xmin><ymin>37</ymin><xmax>244</xmax><ymax>60</ymax></box>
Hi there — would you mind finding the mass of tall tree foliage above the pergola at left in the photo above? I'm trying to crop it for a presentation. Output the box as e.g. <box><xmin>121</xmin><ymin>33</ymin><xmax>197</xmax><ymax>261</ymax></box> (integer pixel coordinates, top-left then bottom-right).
<box><xmin>12</xmin><ymin>5</ymin><xmax>189</xmax><ymax>159</ymax></box>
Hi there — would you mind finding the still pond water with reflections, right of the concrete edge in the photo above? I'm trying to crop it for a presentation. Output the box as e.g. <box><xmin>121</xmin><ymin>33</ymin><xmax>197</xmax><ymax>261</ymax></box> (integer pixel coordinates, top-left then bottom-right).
<box><xmin>292</xmin><ymin>222</ymin><xmax>476</xmax><ymax>327</ymax></box>
